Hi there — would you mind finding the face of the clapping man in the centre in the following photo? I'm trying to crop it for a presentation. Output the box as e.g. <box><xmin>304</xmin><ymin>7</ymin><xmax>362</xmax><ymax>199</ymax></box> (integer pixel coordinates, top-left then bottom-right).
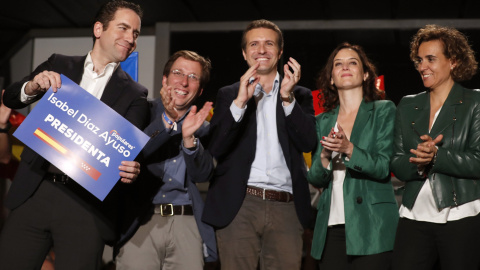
<box><xmin>243</xmin><ymin>28</ymin><xmax>283</xmax><ymax>75</ymax></box>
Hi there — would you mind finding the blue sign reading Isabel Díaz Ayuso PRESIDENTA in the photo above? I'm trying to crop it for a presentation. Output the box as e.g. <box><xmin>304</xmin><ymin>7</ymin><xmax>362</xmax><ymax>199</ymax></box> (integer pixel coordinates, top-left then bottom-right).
<box><xmin>13</xmin><ymin>75</ymin><xmax>149</xmax><ymax>201</ymax></box>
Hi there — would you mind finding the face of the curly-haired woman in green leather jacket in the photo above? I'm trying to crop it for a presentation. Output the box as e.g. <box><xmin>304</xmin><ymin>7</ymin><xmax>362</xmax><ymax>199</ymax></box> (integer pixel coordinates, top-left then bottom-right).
<box><xmin>416</xmin><ymin>40</ymin><xmax>455</xmax><ymax>90</ymax></box>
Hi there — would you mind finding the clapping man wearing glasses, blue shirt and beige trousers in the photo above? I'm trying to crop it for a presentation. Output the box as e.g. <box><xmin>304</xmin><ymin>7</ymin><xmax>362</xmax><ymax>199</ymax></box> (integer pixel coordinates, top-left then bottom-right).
<box><xmin>117</xmin><ymin>51</ymin><xmax>217</xmax><ymax>270</ymax></box>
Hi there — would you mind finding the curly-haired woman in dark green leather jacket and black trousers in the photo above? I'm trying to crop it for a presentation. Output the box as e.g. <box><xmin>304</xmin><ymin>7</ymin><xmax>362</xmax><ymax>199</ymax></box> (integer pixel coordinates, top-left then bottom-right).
<box><xmin>391</xmin><ymin>25</ymin><xmax>480</xmax><ymax>270</ymax></box>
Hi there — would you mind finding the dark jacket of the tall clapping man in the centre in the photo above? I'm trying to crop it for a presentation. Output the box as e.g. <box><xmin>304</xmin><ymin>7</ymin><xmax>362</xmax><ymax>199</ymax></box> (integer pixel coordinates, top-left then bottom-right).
<box><xmin>202</xmin><ymin>80</ymin><xmax>317</xmax><ymax>228</ymax></box>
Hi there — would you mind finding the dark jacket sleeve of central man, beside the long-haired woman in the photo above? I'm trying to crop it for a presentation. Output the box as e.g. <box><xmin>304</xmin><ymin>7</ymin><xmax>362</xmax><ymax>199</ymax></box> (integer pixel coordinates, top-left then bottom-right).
<box><xmin>286</xmin><ymin>87</ymin><xmax>317</xmax><ymax>153</ymax></box>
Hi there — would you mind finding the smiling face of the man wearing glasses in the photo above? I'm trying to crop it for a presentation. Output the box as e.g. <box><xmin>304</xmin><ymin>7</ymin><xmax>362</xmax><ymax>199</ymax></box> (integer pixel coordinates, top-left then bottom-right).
<box><xmin>163</xmin><ymin>57</ymin><xmax>203</xmax><ymax>111</ymax></box>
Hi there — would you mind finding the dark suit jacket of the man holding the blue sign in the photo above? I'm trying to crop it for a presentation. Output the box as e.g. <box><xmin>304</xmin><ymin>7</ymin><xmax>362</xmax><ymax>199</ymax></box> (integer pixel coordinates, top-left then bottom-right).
<box><xmin>3</xmin><ymin>54</ymin><xmax>149</xmax><ymax>244</ymax></box>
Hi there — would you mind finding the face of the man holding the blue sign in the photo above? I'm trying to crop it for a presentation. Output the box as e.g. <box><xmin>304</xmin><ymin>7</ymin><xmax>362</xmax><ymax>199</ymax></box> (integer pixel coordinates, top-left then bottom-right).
<box><xmin>93</xmin><ymin>8</ymin><xmax>141</xmax><ymax>63</ymax></box>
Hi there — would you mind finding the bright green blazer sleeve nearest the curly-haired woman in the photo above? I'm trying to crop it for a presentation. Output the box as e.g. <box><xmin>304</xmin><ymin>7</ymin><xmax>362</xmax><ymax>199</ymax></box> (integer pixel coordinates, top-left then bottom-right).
<box><xmin>345</xmin><ymin>101</ymin><xmax>395</xmax><ymax>181</ymax></box>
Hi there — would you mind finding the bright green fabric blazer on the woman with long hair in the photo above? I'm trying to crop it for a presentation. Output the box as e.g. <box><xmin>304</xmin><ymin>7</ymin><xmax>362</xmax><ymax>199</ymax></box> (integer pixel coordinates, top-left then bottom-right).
<box><xmin>307</xmin><ymin>100</ymin><xmax>398</xmax><ymax>259</ymax></box>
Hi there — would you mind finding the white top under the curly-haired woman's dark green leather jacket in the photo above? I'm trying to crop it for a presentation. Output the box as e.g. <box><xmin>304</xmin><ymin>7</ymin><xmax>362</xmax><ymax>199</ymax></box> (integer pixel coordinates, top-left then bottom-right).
<box><xmin>399</xmin><ymin>108</ymin><xmax>480</xmax><ymax>223</ymax></box>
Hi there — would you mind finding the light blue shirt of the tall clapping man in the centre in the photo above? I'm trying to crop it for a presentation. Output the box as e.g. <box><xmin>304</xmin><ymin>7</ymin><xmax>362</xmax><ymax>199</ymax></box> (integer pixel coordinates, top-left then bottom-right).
<box><xmin>230</xmin><ymin>72</ymin><xmax>295</xmax><ymax>193</ymax></box>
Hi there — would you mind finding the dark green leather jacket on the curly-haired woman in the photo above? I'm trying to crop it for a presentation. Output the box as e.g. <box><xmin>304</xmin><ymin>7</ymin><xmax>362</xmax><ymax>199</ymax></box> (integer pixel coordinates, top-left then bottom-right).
<box><xmin>391</xmin><ymin>83</ymin><xmax>480</xmax><ymax>210</ymax></box>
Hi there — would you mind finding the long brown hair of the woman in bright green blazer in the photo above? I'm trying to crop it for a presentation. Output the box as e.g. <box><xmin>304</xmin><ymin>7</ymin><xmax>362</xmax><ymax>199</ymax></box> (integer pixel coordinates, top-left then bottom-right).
<box><xmin>317</xmin><ymin>42</ymin><xmax>384</xmax><ymax>112</ymax></box>
